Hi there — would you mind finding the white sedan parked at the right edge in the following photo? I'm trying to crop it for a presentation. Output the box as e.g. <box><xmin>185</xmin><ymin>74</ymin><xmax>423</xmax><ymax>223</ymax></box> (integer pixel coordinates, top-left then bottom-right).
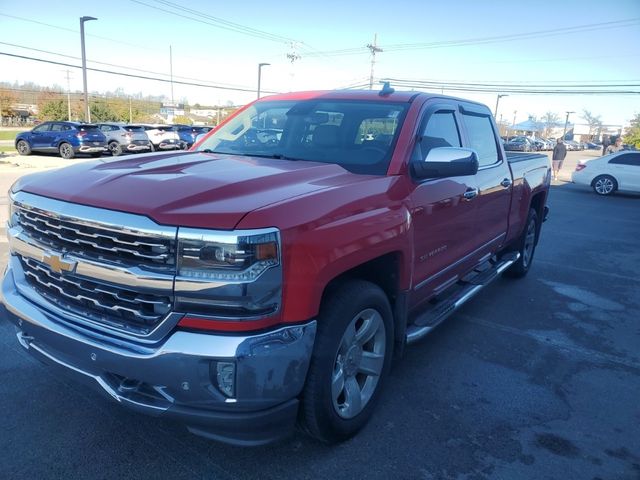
<box><xmin>571</xmin><ymin>150</ymin><xmax>640</xmax><ymax>195</ymax></box>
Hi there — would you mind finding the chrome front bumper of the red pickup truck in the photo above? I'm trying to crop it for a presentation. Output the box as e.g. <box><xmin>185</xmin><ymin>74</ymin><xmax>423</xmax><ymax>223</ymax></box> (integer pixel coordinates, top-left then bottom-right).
<box><xmin>0</xmin><ymin>258</ymin><xmax>316</xmax><ymax>445</ymax></box>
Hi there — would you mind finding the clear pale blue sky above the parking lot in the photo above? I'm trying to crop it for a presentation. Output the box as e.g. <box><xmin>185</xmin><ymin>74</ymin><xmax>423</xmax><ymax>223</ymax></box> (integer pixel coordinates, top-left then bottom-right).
<box><xmin>0</xmin><ymin>0</ymin><xmax>640</xmax><ymax>125</ymax></box>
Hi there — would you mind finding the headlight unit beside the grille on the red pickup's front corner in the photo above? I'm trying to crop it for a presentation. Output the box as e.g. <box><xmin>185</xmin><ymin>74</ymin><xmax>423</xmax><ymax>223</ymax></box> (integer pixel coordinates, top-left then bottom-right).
<box><xmin>175</xmin><ymin>228</ymin><xmax>282</xmax><ymax>319</ymax></box>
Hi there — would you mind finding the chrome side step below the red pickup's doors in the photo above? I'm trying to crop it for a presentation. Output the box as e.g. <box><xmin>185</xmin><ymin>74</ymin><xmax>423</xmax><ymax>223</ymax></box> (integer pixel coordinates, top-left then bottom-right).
<box><xmin>407</xmin><ymin>252</ymin><xmax>520</xmax><ymax>344</ymax></box>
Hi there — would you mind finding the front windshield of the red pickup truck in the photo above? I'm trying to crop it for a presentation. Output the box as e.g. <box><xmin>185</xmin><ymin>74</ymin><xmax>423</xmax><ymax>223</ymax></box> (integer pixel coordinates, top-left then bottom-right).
<box><xmin>192</xmin><ymin>99</ymin><xmax>408</xmax><ymax>175</ymax></box>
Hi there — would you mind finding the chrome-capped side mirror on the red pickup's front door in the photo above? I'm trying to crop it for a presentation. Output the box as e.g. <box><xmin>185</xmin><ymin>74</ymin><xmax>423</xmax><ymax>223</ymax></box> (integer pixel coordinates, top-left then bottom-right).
<box><xmin>411</xmin><ymin>147</ymin><xmax>479</xmax><ymax>179</ymax></box>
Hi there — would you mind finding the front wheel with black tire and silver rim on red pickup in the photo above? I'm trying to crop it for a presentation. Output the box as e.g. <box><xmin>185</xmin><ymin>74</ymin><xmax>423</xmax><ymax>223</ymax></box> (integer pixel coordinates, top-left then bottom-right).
<box><xmin>299</xmin><ymin>280</ymin><xmax>393</xmax><ymax>443</ymax></box>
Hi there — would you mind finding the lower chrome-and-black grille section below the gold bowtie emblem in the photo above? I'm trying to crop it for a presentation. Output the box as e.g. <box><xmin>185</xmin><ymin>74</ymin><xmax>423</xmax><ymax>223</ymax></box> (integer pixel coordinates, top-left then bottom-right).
<box><xmin>21</xmin><ymin>257</ymin><xmax>171</xmax><ymax>335</ymax></box>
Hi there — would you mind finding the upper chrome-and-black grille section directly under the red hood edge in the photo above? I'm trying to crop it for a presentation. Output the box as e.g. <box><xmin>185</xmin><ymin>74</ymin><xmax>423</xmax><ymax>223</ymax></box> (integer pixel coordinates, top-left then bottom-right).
<box><xmin>16</xmin><ymin>206</ymin><xmax>175</xmax><ymax>266</ymax></box>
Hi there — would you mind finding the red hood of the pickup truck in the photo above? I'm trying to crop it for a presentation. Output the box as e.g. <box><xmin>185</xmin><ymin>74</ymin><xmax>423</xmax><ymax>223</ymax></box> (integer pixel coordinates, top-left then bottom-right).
<box><xmin>13</xmin><ymin>152</ymin><xmax>368</xmax><ymax>229</ymax></box>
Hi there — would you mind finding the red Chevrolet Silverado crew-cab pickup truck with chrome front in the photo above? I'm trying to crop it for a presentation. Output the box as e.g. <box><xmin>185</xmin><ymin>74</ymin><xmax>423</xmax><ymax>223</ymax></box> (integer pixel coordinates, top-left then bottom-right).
<box><xmin>2</xmin><ymin>87</ymin><xmax>550</xmax><ymax>445</ymax></box>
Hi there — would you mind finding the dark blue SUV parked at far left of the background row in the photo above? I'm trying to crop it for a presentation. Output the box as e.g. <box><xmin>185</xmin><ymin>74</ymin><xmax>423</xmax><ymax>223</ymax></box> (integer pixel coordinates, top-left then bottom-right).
<box><xmin>15</xmin><ymin>122</ymin><xmax>107</xmax><ymax>159</ymax></box>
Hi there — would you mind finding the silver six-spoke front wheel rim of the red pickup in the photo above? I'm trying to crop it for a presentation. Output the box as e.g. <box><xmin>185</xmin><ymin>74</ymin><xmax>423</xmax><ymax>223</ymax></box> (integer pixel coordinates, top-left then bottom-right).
<box><xmin>331</xmin><ymin>308</ymin><xmax>386</xmax><ymax>419</ymax></box>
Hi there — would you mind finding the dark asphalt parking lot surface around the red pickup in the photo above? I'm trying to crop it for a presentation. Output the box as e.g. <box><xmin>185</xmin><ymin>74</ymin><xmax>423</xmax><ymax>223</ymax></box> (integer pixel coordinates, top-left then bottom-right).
<box><xmin>0</xmin><ymin>152</ymin><xmax>640</xmax><ymax>480</ymax></box>
